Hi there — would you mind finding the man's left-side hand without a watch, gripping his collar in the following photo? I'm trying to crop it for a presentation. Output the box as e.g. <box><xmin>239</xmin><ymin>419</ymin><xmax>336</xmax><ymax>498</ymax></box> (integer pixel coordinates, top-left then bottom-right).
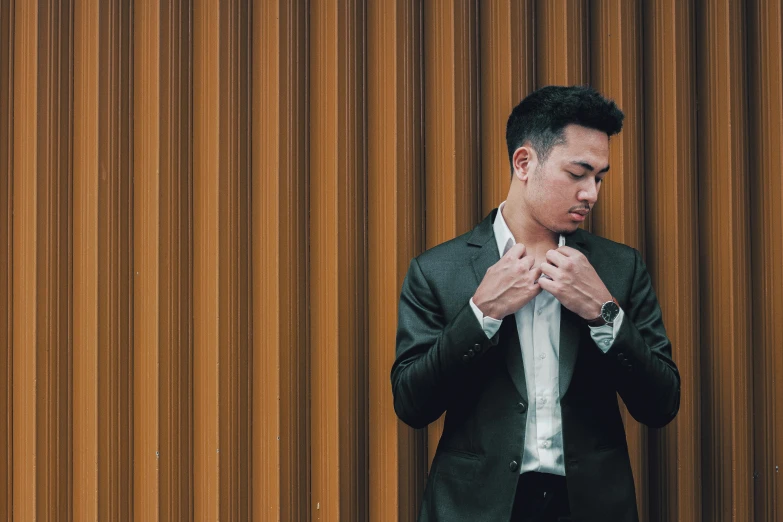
<box><xmin>473</xmin><ymin>243</ymin><xmax>541</xmax><ymax>319</ymax></box>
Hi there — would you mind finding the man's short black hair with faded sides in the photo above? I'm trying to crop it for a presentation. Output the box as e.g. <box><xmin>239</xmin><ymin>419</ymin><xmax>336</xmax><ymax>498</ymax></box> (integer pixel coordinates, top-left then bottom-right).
<box><xmin>506</xmin><ymin>85</ymin><xmax>625</xmax><ymax>165</ymax></box>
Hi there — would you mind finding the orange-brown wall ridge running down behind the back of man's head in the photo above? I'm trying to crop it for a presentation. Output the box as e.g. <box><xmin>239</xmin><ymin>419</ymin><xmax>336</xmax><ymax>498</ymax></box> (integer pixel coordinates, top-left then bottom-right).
<box><xmin>479</xmin><ymin>0</ymin><xmax>535</xmax><ymax>215</ymax></box>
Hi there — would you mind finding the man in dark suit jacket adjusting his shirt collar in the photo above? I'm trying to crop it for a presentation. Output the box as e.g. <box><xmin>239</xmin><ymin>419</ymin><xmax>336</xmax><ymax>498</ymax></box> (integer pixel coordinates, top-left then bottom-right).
<box><xmin>391</xmin><ymin>86</ymin><xmax>680</xmax><ymax>522</ymax></box>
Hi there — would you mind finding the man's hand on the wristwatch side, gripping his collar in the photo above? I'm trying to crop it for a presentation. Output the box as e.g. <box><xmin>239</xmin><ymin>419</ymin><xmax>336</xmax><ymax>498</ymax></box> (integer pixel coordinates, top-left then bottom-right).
<box><xmin>539</xmin><ymin>246</ymin><xmax>612</xmax><ymax>321</ymax></box>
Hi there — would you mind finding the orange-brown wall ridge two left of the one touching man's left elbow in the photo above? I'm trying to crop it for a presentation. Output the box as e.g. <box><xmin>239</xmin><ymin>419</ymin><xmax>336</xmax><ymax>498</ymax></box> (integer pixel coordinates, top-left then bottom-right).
<box><xmin>251</xmin><ymin>0</ymin><xmax>310</xmax><ymax>521</ymax></box>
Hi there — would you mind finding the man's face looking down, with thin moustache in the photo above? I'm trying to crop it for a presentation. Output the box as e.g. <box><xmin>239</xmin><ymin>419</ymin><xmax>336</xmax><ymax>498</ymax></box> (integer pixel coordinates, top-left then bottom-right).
<box><xmin>525</xmin><ymin>124</ymin><xmax>609</xmax><ymax>234</ymax></box>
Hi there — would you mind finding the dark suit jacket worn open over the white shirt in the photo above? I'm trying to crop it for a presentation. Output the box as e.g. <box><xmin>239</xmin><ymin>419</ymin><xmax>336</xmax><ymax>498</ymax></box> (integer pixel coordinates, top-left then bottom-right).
<box><xmin>391</xmin><ymin>210</ymin><xmax>680</xmax><ymax>522</ymax></box>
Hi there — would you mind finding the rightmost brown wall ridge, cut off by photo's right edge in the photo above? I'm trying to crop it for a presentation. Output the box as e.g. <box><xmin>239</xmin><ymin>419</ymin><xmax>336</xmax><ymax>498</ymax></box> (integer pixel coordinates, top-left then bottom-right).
<box><xmin>747</xmin><ymin>1</ymin><xmax>783</xmax><ymax>521</ymax></box>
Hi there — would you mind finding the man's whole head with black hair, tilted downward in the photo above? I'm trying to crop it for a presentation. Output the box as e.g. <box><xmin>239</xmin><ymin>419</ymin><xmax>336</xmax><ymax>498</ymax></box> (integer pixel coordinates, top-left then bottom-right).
<box><xmin>506</xmin><ymin>86</ymin><xmax>623</xmax><ymax>233</ymax></box>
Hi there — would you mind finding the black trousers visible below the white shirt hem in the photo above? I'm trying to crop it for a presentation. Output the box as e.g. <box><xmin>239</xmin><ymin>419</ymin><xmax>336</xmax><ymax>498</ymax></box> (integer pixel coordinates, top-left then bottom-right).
<box><xmin>510</xmin><ymin>473</ymin><xmax>571</xmax><ymax>522</ymax></box>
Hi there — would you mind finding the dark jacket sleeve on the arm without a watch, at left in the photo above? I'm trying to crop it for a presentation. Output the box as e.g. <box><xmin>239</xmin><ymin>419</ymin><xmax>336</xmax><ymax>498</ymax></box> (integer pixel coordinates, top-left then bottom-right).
<box><xmin>391</xmin><ymin>259</ymin><xmax>499</xmax><ymax>428</ymax></box>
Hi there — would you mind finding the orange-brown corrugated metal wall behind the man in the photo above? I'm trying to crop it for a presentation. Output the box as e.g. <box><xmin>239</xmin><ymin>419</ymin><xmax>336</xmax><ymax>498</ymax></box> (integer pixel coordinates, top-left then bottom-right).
<box><xmin>0</xmin><ymin>0</ymin><xmax>783</xmax><ymax>522</ymax></box>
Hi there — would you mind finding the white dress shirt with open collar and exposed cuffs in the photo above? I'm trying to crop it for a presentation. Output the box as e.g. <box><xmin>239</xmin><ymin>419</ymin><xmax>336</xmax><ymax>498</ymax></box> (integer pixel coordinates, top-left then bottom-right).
<box><xmin>470</xmin><ymin>202</ymin><xmax>623</xmax><ymax>476</ymax></box>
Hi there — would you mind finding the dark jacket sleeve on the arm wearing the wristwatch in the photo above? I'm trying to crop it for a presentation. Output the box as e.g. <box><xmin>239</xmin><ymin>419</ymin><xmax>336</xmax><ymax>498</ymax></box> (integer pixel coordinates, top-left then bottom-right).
<box><xmin>605</xmin><ymin>252</ymin><xmax>680</xmax><ymax>428</ymax></box>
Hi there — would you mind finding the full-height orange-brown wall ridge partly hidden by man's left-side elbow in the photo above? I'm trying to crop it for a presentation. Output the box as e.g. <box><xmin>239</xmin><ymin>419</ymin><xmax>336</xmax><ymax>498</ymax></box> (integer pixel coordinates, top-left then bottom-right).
<box><xmin>367</xmin><ymin>0</ymin><xmax>426</xmax><ymax>522</ymax></box>
